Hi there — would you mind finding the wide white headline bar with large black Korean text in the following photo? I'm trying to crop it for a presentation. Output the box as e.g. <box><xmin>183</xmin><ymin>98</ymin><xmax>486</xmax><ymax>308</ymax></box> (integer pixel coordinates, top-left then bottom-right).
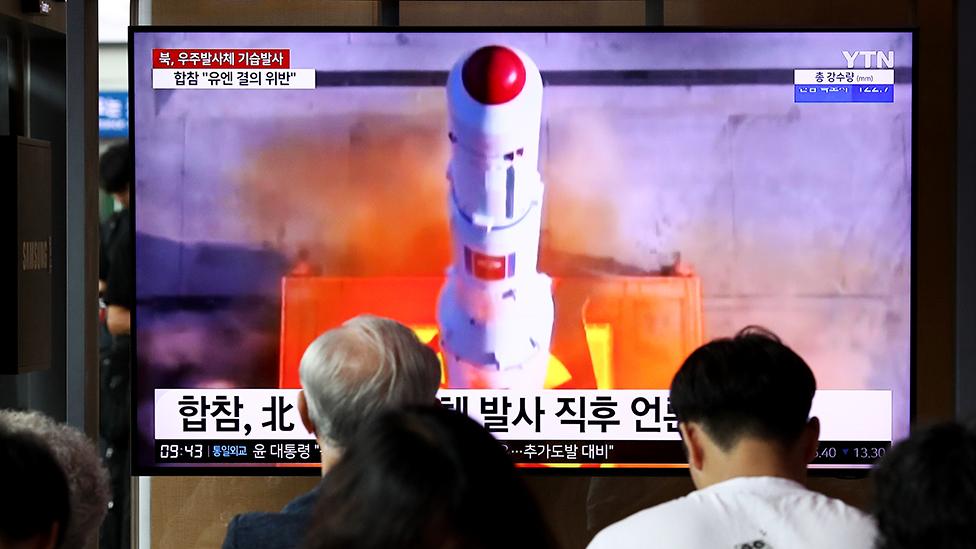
<box><xmin>155</xmin><ymin>389</ymin><xmax>891</xmax><ymax>442</ymax></box>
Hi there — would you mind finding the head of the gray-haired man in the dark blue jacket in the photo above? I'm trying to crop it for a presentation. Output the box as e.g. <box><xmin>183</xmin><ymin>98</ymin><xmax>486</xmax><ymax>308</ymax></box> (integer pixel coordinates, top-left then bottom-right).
<box><xmin>299</xmin><ymin>315</ymin><xmax>441</xmax><ymax>461</ymax></box>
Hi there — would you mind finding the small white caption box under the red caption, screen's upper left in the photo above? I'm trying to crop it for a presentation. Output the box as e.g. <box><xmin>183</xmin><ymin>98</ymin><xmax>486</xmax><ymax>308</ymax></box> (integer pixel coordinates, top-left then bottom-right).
<box><xmin>153</xmin><ymin>69</ymin><xmax>315</xmax><ymax>90</ymax></box>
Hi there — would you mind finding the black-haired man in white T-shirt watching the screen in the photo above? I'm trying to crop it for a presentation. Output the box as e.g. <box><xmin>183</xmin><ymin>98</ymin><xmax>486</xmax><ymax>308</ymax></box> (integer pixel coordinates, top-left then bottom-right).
<box><xmin>589</xmin><ymin>327</ymin><xmax>876</xmax><ymax>549</ymax></box>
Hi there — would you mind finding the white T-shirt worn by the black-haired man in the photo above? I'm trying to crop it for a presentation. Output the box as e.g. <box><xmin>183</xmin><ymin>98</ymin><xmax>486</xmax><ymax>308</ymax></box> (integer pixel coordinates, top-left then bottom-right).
<box><xmin>589</xmin><ymin>477</ymin><xmax>877</xmax><ymax>549</ymax></box>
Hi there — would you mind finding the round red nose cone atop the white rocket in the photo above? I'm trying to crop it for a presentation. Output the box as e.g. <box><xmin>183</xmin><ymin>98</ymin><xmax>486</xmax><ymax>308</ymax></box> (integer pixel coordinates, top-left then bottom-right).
<box><xmin>461</xmin><ymin>46</ymin><xmax>525</xmax><ymax>105</ymax></box>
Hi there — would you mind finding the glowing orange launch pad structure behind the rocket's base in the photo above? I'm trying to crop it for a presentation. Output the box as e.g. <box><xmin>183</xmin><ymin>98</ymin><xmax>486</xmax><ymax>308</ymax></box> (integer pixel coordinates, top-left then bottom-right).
<box><xmin>278</xmin><ymin>276</ymin><xmax>704</xmax><ymax>389</ymax></box>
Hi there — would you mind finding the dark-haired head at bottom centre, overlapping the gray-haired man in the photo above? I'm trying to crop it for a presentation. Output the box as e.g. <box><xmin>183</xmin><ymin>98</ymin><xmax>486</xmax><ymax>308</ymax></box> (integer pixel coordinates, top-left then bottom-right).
<box><xmin>305</xmin><ymin>405</ymin><xmax>552</xmax><ymax>549</ymax></box>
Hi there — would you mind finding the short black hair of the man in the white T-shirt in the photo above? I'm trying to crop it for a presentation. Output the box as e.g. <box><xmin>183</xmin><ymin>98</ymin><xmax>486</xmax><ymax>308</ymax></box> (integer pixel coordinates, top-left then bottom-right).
<box><xmin>671</xmin><ymin>326</ymin><xmax>817</xmax><ymax>450</ymax></box>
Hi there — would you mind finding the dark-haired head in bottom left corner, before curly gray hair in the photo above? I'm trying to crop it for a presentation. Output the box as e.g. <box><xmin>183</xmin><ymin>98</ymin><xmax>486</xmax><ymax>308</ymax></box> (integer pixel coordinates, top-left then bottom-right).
<box><xmin>0</xmin><ymin>428</ymin><xmax>69</xmax><ymax>549</ymax></box>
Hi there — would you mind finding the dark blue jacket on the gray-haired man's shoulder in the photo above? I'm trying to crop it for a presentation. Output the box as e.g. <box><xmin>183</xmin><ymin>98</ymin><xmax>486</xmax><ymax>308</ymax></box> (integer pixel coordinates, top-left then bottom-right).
<box><xmin>223</xmin><ymin>487</ymin><xmax>319</xmax><ymax>549</ymax></box>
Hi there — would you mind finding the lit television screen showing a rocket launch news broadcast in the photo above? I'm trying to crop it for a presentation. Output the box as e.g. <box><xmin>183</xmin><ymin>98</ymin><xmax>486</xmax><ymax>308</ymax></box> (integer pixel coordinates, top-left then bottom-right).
<box><xmin>130</xmin><ymin>27</ymin><xmax>913</xmax><ymax>474</ymax></box>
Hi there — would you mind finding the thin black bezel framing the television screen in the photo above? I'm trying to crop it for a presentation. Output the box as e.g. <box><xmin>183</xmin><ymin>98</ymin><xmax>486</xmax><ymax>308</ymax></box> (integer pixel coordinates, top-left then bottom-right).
<box><xmin>127</xmin><ymin>25</ymin><xmax>919</xmax><ymax>479</ymax></box>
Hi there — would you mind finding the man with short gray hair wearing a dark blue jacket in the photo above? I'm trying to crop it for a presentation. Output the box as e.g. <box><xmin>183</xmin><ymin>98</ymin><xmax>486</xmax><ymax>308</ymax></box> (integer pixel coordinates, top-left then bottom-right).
<box><xmin>223</xmin><ymin>315</ymin><xmax>441</xmax><ymax>549</ymax></box>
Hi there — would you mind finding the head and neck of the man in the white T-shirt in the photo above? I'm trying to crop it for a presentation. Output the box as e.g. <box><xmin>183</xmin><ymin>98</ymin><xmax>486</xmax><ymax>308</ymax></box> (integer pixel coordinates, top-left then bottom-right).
<box><xmin>671</xmin><ymin>326</ymin><xmax>820</xmax><ymax>488</ymax></box>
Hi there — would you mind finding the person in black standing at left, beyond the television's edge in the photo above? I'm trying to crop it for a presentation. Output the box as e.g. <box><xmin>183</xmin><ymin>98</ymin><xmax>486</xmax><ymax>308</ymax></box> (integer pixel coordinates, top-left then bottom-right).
<box><xmin>98</xmin><ymin>142</ymin><xmax>135</xmax><ymax>549</ymax></box>
